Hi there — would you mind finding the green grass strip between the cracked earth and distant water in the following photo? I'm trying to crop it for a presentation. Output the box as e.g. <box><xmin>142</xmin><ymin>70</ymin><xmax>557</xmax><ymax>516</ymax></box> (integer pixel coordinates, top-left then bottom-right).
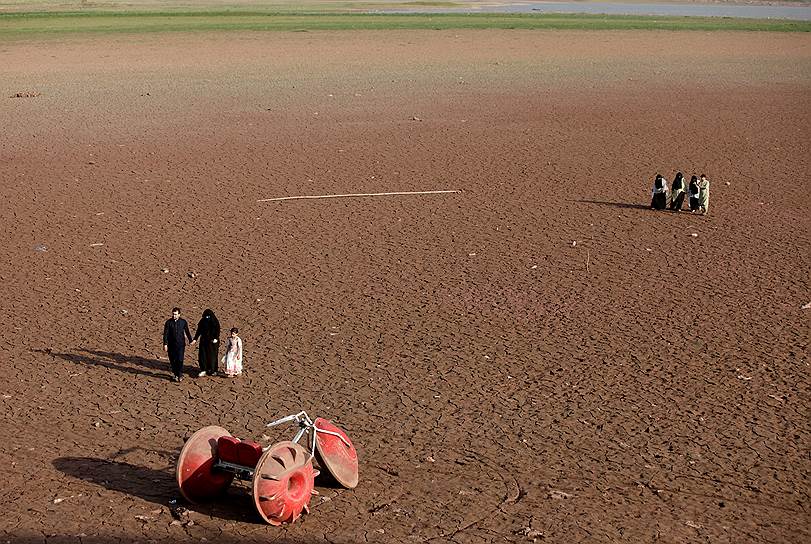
<box><xmin>0</xmin><ymin>10</ymin><xmax>811</xmax><ymax>40</ymax></box>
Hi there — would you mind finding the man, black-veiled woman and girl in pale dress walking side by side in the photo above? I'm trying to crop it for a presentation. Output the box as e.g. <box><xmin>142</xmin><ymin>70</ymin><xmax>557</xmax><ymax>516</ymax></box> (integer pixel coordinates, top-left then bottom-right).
<box><xmin>163</xmin><ymin>308</ymin><xmax>242</xmax><ymax>382</ymax></box>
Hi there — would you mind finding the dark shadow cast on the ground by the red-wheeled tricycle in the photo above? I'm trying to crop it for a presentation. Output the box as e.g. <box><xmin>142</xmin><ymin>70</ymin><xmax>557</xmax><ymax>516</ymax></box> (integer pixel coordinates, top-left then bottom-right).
<box><xmin>53</xmin><ymin>457</ymin><xmax>261</xmax><ymax>523</ymax></box>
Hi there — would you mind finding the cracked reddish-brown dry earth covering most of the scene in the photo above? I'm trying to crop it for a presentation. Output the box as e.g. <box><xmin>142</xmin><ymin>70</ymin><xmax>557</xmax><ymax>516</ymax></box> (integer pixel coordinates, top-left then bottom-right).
<box><xmin>0</xmin><ymin>31</ymin><xmax>811</xmax><ymax>544</ymax></box>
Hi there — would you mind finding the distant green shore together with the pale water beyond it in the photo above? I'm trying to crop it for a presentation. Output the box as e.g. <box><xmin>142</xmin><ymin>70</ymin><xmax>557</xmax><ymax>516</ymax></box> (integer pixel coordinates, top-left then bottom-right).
<box><xmin>0</xmin><ymin>0</ymin><xmax>811</xmax><ymax>40</ymax></box>
